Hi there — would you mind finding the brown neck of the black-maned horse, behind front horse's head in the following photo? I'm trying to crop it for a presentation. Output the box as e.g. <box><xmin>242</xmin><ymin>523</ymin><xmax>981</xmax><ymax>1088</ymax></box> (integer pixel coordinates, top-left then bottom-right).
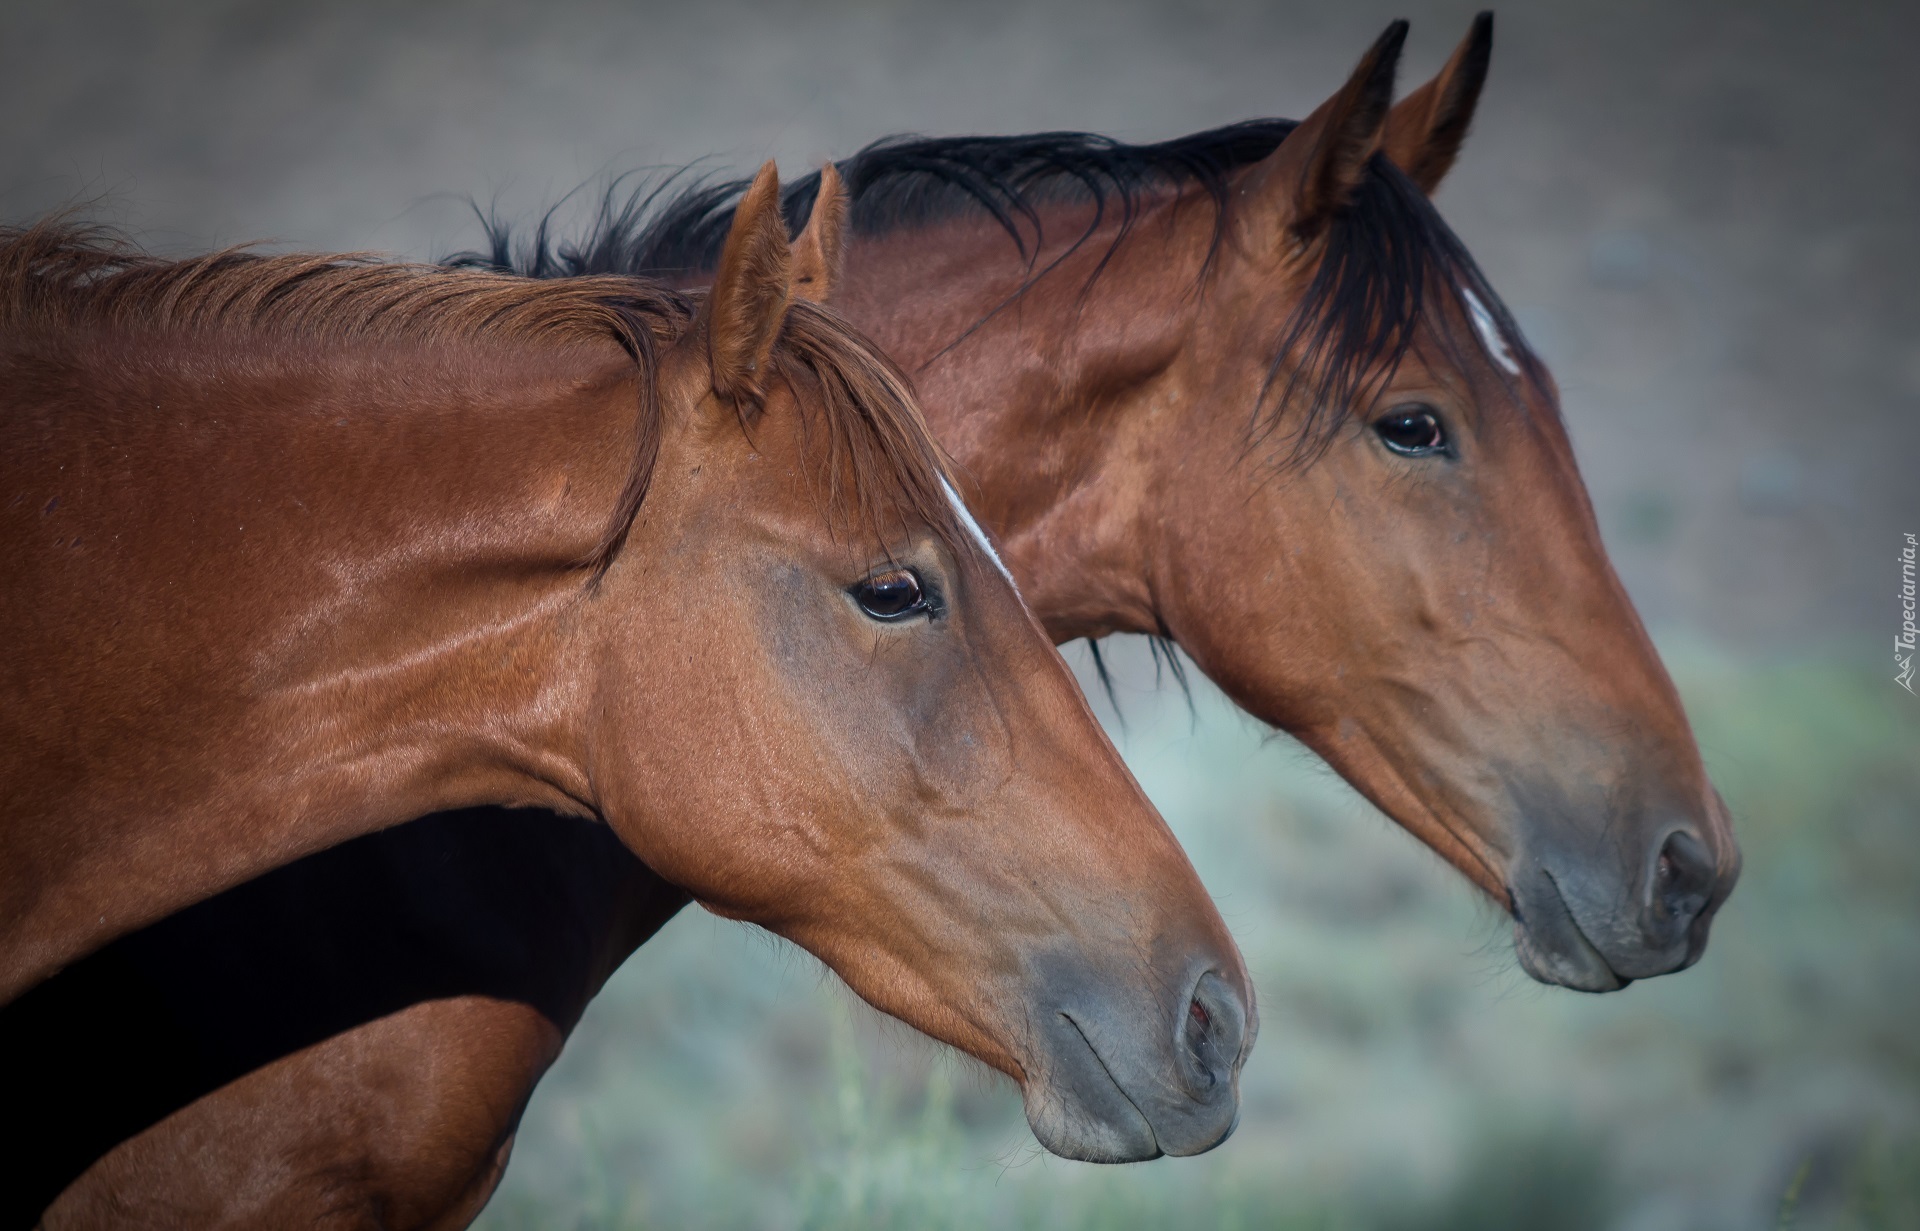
<box><xmin>835</xmin><ymin>200</ymin><xmax>1208</xmax><ymax>641</ymax></box>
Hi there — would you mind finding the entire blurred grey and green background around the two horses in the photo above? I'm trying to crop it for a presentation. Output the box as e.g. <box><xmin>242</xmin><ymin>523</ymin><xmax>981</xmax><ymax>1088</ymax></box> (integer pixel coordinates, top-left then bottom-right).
<box><xmin>0</xmin><ymin>0</ymin><xmax>1920</xmax><ymax>1229</ymax></box>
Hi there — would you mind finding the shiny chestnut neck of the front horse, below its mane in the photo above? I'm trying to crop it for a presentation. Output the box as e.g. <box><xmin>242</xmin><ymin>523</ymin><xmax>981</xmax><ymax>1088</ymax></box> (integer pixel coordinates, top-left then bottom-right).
<box><xmin>0</xmin><ymin>328</ymin><xmax>634</xmax><ymax>999</ymax></box>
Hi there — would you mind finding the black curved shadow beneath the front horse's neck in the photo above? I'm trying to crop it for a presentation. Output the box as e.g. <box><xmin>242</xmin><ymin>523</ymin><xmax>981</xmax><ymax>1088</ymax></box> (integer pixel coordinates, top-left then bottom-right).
<box><xmin>0</xmin><ymin>809</ymin><xmax>687</xmax><ymax>1229</ymax></box>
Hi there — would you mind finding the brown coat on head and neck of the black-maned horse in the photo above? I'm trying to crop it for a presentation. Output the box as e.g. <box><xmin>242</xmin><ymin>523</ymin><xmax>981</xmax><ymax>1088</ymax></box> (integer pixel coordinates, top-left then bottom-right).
<box><xmin>33</xmin><ymin>17</ymin><xmax>1738</xmax><ymax>1221</ymax></box>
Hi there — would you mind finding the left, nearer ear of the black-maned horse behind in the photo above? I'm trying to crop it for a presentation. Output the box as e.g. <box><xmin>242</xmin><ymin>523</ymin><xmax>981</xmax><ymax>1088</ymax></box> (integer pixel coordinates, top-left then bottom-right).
<box><xmin>1246</xmin><ymin>21</ymin><xmax>1407</xmax><ymax>240</ymax></box>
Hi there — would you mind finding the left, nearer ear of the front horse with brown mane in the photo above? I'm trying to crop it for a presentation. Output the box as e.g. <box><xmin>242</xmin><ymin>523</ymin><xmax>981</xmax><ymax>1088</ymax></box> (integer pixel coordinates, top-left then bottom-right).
<box><xmin>705</xmin><ymin>161</ymin><xmax>793</xmax><ymax>401</ymax></box>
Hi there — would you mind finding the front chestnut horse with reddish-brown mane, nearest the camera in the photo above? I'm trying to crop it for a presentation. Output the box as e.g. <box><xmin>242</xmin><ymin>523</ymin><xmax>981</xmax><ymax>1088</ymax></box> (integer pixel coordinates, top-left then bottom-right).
<box><xmin>0</xmin><ymin>167</ymin><xmax>1254</xmax><ymax>1225</ymax></box>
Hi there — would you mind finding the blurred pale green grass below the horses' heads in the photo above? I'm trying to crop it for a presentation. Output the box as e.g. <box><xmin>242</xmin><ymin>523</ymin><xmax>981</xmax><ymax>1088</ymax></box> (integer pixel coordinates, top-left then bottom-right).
<box><xmin>480</xmin><ymin>643</ymin><xmax>1920</xmax><ymax>1231</ymax></box>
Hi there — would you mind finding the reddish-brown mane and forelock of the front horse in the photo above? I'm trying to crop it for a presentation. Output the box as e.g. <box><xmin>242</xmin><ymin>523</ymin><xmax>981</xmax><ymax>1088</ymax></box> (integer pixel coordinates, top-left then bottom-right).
<box><xmin>0</xmin><ymin>219</ymin><xmax>970</xmax><ymax>578</ymax></box>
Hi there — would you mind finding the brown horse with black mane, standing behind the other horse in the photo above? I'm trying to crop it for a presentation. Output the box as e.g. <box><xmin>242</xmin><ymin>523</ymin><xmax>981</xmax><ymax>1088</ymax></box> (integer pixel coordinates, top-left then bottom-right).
<box><xmin>11</xmin><ymin>15</ymin><xmax>1738</xmax><ymax>1229</ymax></box>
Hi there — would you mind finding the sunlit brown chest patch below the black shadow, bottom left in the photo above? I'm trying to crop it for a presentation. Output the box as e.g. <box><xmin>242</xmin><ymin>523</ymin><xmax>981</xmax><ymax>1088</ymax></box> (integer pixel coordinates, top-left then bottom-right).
<box><xmin>42</xmin><ymin>997</ymin><xmax>563</xmax><ymax>1231</ymax></box>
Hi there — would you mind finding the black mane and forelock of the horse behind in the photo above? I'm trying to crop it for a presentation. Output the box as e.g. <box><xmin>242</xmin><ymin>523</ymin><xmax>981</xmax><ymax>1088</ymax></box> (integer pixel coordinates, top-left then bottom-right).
<box><xmin>447</xmin><ymin>119</ymin><xmax>1544</xmax><ymax>461</ymax></box>
